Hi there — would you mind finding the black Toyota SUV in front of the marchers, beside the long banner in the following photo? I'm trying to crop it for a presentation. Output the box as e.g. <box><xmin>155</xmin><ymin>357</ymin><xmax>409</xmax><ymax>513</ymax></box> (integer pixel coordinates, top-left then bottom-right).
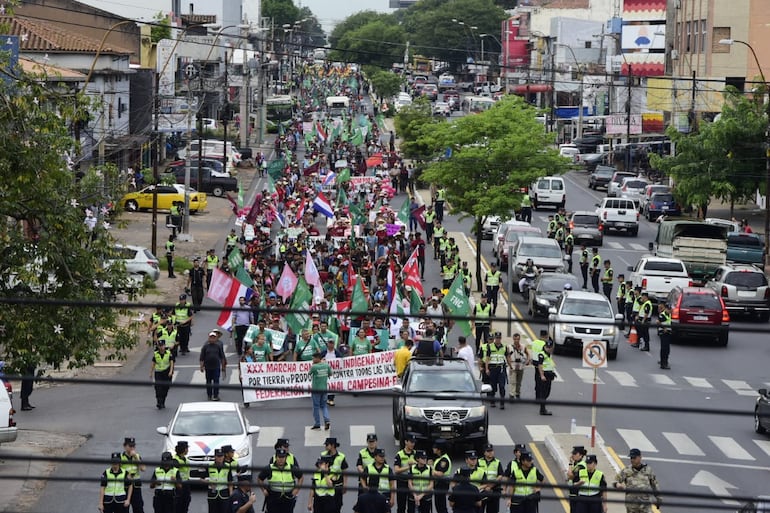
<box><xmin>393</xmin><ymin>358</ymin><xmax>491</xmax><ymax>450</ymax></box>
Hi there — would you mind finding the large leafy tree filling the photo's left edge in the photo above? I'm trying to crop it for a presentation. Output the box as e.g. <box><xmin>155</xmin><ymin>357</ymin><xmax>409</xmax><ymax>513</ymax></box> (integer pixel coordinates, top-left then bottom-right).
<box><xmin>0</xmin><ymin>68</ymin><xmax>135</xmax><ymax>373</ymax></box>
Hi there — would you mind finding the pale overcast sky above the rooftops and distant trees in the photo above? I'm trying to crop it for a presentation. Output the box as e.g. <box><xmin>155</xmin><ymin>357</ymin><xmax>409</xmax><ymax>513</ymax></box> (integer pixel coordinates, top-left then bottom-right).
<box><xmin>80</xmin><ymin>0</ymin><xmax>392</xmax><ymax>34</ymax></box>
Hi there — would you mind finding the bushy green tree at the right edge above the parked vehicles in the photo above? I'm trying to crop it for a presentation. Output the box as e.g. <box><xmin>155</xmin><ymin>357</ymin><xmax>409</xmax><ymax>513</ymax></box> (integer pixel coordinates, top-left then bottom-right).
<box><xmin>650</xmin><ymin>89</ymin><xmax>767</xmax><ymax>218</ymax></box>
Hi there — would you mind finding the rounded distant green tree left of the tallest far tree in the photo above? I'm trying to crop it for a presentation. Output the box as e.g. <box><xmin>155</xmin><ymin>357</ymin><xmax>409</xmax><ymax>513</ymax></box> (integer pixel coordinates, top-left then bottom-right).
<box><xmin>329</xmin><ymin>18</ymin><xmax>406</xmax><ymax>69</ymax></box>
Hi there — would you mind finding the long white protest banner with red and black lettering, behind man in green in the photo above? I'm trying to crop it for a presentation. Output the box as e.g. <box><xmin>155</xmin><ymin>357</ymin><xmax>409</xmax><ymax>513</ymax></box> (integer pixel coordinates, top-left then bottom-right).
<box><xmin>241</xmin><ymin>351</ymin><xmax>398</xmax><ymax>403</ymax></box>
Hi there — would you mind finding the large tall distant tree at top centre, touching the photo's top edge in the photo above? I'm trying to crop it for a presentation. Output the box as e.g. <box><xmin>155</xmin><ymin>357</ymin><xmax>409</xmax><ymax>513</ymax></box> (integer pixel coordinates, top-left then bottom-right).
<box><xmin>403</xmin><ymin>0</ymin><xmax>506</xmax><ymax>68</ymax></box>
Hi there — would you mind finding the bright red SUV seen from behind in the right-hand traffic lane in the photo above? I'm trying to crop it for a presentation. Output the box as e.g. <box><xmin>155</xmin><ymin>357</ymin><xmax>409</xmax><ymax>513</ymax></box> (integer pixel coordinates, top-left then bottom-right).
<box><xmin>666</xmin><ymin>287</ymin><xmax>730</xmax><ymax>346</ymax></box>
